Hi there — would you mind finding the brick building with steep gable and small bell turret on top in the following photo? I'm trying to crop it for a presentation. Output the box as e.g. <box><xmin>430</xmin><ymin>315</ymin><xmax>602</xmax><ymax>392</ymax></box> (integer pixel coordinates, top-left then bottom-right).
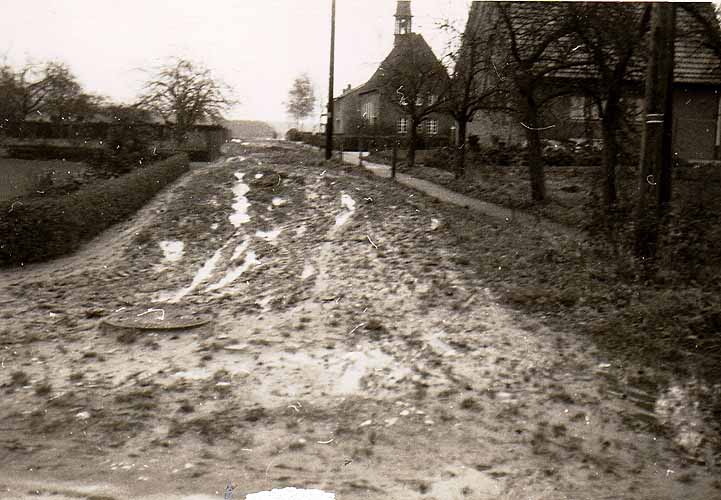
<box><xmin>333</xmin><ymin>0</ymin><xmax>453</xmax><ymax>145</ymax></box>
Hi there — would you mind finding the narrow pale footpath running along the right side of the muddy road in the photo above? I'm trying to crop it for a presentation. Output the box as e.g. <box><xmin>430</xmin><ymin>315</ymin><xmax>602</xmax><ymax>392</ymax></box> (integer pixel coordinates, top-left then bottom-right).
<box><xmin>343</xmin><ymin>152</ymin><xmax>584</xmax><ymax>240</ymax></box>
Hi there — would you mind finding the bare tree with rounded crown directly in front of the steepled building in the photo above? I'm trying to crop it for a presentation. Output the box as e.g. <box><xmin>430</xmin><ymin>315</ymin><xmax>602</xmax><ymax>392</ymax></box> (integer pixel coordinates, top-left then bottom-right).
<box><xmin>380</xmin><ymin>35</ymin><xmax>449</xmax><ymax>168</ymax></box>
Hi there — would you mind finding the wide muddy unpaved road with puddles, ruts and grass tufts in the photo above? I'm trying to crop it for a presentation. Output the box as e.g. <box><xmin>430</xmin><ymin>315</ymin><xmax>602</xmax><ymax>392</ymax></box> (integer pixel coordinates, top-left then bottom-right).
<box><xmin>0</xmin><ymin>142</ymin><xmax>721</xmax><ymax>500</ymax></box>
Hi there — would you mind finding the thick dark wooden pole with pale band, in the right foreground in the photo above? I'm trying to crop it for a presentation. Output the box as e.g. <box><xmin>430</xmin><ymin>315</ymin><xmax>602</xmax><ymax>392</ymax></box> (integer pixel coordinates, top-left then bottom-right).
<box><xmin>635</xmin><ymin>2</ymin><xmax>676</xmax><ymax>258</ymax></box>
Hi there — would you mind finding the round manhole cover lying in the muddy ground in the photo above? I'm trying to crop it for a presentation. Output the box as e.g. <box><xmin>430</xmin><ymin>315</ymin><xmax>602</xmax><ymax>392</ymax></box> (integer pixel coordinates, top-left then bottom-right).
<box><xmin>103</xmin><ymin>306</ymin><xmax>213</xmax><ymax>330</ymax></box>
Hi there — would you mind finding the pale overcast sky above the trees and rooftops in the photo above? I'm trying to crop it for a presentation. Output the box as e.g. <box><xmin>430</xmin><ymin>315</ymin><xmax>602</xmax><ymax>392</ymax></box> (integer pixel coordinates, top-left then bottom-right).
<box><xmin>0</xmin><ymin>0</ymin><xmax>470</xmax><ymax>125</ymax></box>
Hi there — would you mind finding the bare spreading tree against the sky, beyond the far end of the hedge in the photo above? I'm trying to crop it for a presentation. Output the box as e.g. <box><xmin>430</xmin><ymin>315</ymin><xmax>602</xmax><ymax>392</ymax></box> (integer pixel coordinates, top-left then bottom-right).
<box><xmin>137</xmin><ymin>59</ymin><xmax>236</xmax><ymax>144</ymax></box>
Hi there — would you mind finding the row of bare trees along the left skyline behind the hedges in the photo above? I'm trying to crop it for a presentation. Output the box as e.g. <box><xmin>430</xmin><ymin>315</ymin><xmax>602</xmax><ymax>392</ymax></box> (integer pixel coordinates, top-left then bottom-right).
<box><xmin>0</xmin><ymin>58</ymin><xmax>236</xmax><ymax>144</ymax></box>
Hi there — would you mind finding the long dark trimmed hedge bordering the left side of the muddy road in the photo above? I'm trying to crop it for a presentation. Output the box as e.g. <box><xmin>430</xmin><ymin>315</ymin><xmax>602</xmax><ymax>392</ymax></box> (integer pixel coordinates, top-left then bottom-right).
<box><xmin>0</xmin><ymin>154</ymin><xmax>189</xmax><ymax>266</ymax></box>
